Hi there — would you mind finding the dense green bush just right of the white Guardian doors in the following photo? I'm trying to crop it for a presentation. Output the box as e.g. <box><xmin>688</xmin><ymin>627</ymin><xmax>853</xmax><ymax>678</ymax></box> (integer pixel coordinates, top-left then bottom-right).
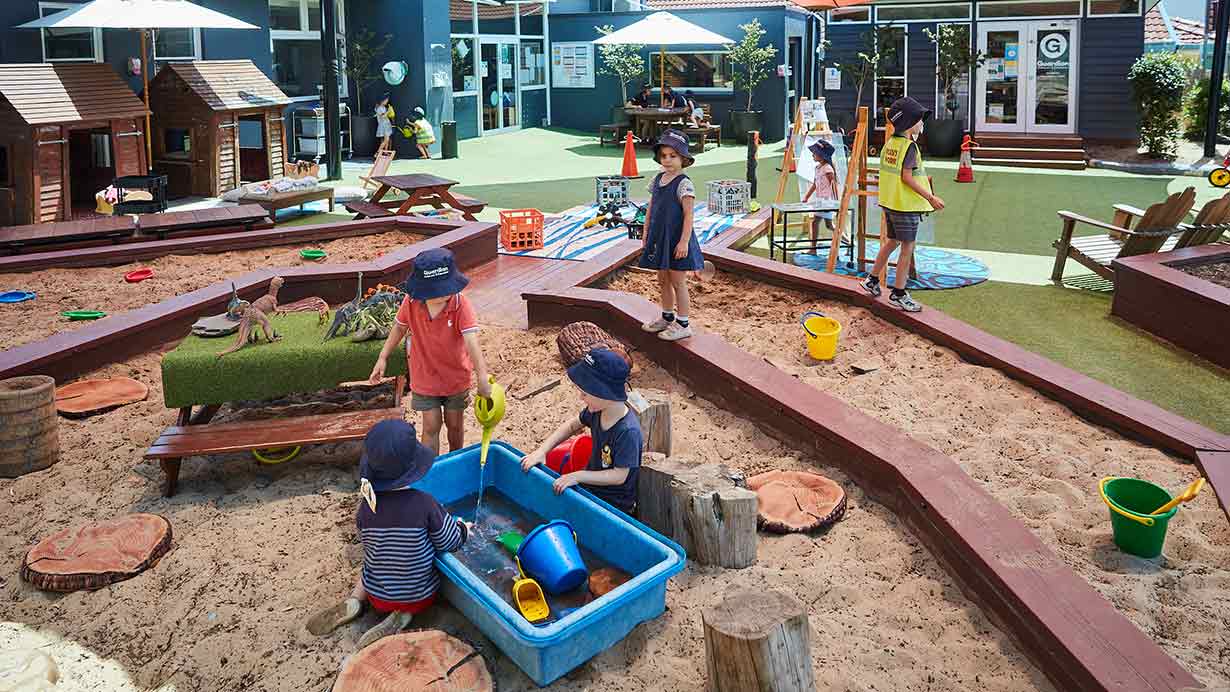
<box><xmin>1128</xmin><ymin>53</ymin><xmax>1187</xmax><ymax>159</ymax></box>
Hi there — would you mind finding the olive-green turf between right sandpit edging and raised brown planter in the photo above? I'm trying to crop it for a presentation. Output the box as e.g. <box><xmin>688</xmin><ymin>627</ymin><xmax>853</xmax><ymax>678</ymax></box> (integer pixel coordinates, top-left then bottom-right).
<box><xmin>913</xmin><ymin>281</ymin><xmax>1230</xmax><ymax>434</ymax></box>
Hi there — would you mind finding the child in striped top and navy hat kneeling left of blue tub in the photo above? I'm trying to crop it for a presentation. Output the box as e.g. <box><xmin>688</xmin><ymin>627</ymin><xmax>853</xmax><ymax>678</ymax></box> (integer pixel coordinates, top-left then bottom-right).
<box><xmin>308</xmin><ymin>420</ymin><xmax>470</xmax><ymax>649</ymax></box>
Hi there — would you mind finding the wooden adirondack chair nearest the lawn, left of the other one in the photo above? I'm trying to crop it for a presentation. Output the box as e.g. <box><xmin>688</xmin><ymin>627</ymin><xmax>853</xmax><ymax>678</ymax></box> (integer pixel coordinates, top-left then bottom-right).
<box><xmin>1050</xmin><ymin>187</ymin><xmax>1196</xmax><ymax>283</ymax></box>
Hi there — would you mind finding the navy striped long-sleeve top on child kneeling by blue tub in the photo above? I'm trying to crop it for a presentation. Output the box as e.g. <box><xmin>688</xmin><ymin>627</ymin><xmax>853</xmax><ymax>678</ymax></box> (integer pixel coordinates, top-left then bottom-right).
<box><xmin>355</xmin><ymin>489</ymin><xmax>467</xmax><ymax>604</ymax></box>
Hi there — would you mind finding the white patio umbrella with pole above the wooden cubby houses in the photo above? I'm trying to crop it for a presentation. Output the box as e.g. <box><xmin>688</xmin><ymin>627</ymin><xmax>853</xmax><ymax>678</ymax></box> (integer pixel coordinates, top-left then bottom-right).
<box><xmin>17</xmin><ymin>0</ymin><xmax>261</xmax><ymax>167</ymax></box>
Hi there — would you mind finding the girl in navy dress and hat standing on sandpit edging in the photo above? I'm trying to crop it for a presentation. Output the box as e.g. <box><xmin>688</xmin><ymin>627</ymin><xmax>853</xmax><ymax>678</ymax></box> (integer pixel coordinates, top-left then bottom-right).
<box><xmin>640</xmin><ymin>129</ymin><xmax>705</xmax><ymax>342</ymax></box>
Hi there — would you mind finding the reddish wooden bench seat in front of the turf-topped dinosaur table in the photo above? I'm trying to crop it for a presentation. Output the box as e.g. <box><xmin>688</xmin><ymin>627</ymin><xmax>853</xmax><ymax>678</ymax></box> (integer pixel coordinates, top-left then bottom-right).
<box><xmin>145</xmin><ymin>404</ymin><xmax>402</xmax><ymax>498</ymax></box>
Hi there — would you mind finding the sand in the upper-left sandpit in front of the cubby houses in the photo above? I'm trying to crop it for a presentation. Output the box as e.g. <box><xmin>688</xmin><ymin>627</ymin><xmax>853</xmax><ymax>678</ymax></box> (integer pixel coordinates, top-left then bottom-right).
<box><xmin>0</xmin><ymin>231</ymin><xmax>422</xmax><ymax>348</ymax></box>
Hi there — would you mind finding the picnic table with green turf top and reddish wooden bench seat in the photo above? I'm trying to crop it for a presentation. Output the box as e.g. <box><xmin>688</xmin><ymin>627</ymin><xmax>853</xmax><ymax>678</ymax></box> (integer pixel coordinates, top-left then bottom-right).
<box><xmin>145</xmin><ymin>312</ymin><xmax>406</xmax><ymax>497</ymax></box>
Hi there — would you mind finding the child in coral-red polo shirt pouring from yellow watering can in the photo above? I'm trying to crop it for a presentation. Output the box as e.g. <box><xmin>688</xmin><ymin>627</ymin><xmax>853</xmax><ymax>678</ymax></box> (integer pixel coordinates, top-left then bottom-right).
<box><xmin>369</xmin><ymin>248</ymin><xmax>491</xmax><ymax>455</ymax></box>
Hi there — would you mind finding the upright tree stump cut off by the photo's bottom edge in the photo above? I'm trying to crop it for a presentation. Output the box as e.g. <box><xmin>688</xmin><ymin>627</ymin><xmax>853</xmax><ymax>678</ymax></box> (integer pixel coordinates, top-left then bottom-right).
<box><xmin>701</xmin><ymin>591</ymin><xmax>815</xmax><ymax>692</ymax></box>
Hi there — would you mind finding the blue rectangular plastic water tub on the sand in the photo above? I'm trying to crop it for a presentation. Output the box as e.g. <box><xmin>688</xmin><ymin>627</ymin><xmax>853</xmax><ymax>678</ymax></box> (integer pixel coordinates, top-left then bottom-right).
<box><xmin>415</xmin><ymin>442</ymin><xmax>686</xmax><ymax>686</ymax></box>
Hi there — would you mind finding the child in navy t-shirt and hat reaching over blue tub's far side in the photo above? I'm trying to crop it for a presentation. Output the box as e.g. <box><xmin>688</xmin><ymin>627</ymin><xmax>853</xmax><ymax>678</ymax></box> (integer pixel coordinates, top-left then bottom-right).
<box><xmin>522</xmin><ymin>348</ymin><xmax>642</xmax><ymax>514</ymax></box>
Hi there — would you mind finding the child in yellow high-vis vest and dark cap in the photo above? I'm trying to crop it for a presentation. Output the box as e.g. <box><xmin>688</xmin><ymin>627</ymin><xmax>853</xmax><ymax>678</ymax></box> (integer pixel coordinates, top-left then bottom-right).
<box><xmin>862</xmin><ymin>96</ymin><xmax>943</xmax><ymax>312</ymax></box>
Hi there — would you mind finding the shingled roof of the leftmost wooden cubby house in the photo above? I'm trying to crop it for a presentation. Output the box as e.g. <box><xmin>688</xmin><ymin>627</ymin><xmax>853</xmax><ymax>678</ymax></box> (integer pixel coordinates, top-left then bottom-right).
<box><xmin>0</xmin><ymin>63</ymin><xmax>145</xmax><ymax>125</ymax></box>
